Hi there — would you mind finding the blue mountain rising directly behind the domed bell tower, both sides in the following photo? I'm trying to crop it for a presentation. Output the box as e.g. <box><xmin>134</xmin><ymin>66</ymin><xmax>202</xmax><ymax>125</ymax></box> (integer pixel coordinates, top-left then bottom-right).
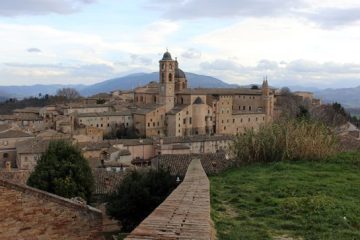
<box><xmin>80</xmin><ymin>72</ymin><xmax>237</xmax><ymax>96</ymax></box>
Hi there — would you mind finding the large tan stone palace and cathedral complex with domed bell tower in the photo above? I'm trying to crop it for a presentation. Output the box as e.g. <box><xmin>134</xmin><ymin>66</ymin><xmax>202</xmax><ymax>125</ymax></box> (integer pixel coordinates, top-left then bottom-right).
<box><xmin>133</xmin><ymin>52</ymin><xmax>275</xmax><ymax>137</ymax></box>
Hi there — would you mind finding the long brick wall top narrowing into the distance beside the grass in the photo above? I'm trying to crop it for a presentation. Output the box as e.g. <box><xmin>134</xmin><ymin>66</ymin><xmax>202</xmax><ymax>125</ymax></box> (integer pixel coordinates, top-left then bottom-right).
<box><xmin>126</xmin><ymin>159</ymin><xmax>215</xmax><ymax>240</ymax></box>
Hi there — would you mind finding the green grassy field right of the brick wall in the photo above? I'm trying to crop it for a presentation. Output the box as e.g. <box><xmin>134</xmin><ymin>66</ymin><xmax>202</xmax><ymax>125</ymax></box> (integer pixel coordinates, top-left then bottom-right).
<box><xmin>210</xmin><ymin>153</ymin><xmax>360</xmax><ymax>240</ymax></box>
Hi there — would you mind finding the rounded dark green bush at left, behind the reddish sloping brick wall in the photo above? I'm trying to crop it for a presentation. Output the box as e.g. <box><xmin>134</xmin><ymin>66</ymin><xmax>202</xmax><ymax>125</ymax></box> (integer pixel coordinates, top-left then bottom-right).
<box><xmin>27</xmin><ymin>141</ymin><xmax>94</xmax><ymax>201</ymax></box>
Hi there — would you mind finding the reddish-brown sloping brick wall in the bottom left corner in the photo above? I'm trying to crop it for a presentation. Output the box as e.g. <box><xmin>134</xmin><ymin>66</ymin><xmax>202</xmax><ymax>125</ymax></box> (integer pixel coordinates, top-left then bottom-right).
<box><xmin>0</xmin><ymin>179</ymin><xmax>102</xmax><ymax>240</ymax></box>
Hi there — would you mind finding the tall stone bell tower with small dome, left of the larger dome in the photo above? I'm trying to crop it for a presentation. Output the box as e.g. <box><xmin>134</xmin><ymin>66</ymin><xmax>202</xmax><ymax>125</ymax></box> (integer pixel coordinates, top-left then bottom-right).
<box><xmin>159</xmin><ymin>51</ymin><xmax>176</xmax><ymax>112</ymax></box>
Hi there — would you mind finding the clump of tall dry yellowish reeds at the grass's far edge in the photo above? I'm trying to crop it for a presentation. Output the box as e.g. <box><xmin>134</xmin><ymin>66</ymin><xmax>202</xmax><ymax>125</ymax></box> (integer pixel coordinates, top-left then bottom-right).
<box><xmin>232</xmin><ymin>120</ymin><xmax>336</xmax><ymax>163</ymax></box>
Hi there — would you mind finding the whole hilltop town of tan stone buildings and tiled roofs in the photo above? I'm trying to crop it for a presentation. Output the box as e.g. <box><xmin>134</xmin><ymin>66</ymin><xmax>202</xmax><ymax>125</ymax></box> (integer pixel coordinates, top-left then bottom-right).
<box><xmin>0</xmin><ymin>52</ymin><xmax>320</xmax><ymax>171</ymax></box>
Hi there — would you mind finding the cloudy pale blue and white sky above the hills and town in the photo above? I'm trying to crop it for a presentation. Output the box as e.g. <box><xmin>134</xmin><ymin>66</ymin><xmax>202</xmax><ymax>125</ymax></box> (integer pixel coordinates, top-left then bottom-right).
<box><xmin>0</xmin><ymin>0</ymin><xmax>360</xmax><ymax>88</ymax></box>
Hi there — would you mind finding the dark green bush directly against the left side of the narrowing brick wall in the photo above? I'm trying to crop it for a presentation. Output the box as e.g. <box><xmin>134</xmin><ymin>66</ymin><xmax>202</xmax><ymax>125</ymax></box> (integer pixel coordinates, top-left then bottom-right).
<box><xmin>106</xmin><ymin>169</ymin><xmax>176</xmax><ymax>232</ymax></box>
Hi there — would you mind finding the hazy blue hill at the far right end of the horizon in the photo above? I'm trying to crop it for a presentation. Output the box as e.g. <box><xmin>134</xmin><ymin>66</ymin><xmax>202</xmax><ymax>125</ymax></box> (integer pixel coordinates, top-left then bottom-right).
<box><xmin>315</xmin><ymin>86</ymin><xmax>360</xmax><ymax>108</ymax></box>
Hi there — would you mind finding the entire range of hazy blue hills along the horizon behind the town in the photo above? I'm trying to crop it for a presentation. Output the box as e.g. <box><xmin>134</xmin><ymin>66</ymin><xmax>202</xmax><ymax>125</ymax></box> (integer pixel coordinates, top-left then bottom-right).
<box><xmin>0</xmin><ymin>72</ymin><xmax>360</xmax><ymax>108</ymax></box>
